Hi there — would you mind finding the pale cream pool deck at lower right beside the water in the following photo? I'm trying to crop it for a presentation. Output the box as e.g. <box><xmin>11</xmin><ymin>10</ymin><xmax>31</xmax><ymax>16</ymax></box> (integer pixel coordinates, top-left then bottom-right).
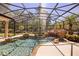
<box><xmin>32</xmin><ymin>42</ymin><xmax>79</xmax><ymax>56</ymax></box>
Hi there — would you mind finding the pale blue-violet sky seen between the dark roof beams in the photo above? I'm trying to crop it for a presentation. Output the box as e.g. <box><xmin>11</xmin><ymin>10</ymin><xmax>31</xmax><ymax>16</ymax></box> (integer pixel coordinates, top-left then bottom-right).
<box><xmin>7</xmin><ymin>3</ymin><xmax>79</xmax><ymax>20</ymax></box>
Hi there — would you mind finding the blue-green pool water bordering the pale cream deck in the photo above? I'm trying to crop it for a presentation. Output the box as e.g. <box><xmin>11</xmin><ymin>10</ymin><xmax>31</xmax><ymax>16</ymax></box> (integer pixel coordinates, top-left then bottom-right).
<box><xmin>0</xmin><ymin>37</ymin><xmax>53</xmax><ymax>56</ymax></box>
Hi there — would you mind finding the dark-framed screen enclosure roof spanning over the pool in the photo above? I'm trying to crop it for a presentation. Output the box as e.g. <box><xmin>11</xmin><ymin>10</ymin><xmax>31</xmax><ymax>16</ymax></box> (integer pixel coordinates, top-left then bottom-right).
<box><xmin>0</xmin><ymin>3</ymin><xmax>79</xmax><ymax>21</ymax></box>
